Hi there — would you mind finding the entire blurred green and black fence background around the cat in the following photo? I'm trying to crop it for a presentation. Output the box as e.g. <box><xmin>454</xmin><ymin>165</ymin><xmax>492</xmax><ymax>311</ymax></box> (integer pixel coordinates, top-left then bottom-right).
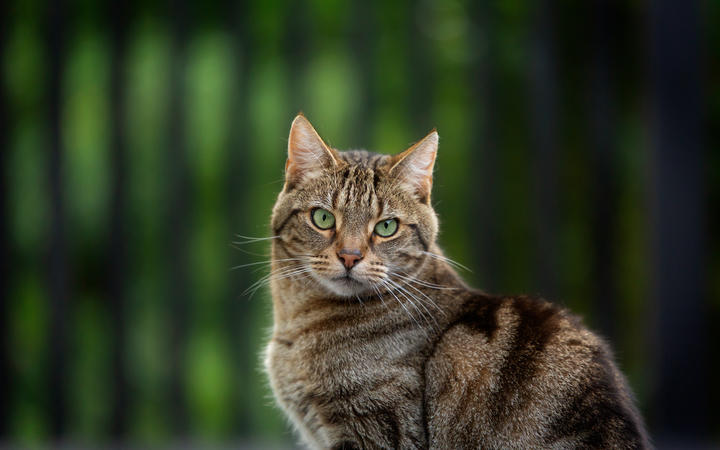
<box><xmin>0</xmin><ymin>0</ymin><xmax>720</xmax><ymax>448</ymax></box>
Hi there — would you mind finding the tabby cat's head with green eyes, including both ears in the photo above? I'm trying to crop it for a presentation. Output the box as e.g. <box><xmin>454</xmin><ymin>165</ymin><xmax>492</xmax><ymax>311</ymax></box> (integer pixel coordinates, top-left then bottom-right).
<box><xmin>272</xmin><ymin>115</ymin><xmax>438</xmax><ymax>297</ymax></box>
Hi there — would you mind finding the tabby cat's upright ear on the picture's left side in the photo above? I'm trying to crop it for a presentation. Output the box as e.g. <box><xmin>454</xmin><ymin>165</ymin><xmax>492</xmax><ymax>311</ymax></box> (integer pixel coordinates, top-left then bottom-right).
<box><xmin>285</xmin><ymin>114</ymin><xmax>339</xmax><ymax>190</ymax></box>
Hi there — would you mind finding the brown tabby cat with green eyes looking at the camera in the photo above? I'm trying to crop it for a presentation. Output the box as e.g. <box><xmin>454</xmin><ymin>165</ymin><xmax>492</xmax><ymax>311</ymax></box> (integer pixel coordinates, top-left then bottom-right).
<box><xmin>265</xmin><ymin>114</ymin><xmax>650</xmax><ymax>449</ymax></box>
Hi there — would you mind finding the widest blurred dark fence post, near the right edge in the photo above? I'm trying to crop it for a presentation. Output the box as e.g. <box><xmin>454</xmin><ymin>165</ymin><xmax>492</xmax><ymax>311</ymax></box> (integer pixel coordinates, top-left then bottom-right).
<box><xmin>650</xmin><ymin>0</ymin><xmax>717</xmax><ymax>437</ymax></box>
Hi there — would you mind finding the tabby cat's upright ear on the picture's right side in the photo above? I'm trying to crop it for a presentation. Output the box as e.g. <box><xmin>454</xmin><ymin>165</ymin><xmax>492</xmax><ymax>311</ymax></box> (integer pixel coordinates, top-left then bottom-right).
<box><xmin>390</xmin><ymin>130</ymin><xmax>438</xmax><ymax>204</ymax></box>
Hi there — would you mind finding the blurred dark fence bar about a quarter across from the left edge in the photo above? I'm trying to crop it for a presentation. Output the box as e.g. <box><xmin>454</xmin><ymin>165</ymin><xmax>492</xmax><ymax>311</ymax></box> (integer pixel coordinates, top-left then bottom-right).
<box><xmin>165</xmin><ymin>0</ymin><xmax>189</xmax><ymax>436</ymax></box>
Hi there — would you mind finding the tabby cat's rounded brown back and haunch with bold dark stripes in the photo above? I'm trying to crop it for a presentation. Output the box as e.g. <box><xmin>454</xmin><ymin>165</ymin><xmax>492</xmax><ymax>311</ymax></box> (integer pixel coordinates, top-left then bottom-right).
<box><xmin>425</xmin><ymin>293</ymin><xmax>647</xmax><ymax>448</ymax></box>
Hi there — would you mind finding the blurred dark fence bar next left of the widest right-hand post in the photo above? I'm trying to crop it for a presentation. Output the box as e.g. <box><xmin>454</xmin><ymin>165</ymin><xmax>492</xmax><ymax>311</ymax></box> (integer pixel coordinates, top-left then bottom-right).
<box><xmin>589</xmin><ymin>0</ymin><xmax>618</xmax><ymax>339</ymax></box>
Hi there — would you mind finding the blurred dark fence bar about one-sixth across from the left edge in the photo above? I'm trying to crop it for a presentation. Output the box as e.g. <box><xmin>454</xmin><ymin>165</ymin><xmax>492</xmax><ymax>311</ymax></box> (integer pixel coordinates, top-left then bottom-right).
<box><xmin>108</xmin><ymin>2</ymin><xmax>128</xmax><ymax>439</ymax></box>
